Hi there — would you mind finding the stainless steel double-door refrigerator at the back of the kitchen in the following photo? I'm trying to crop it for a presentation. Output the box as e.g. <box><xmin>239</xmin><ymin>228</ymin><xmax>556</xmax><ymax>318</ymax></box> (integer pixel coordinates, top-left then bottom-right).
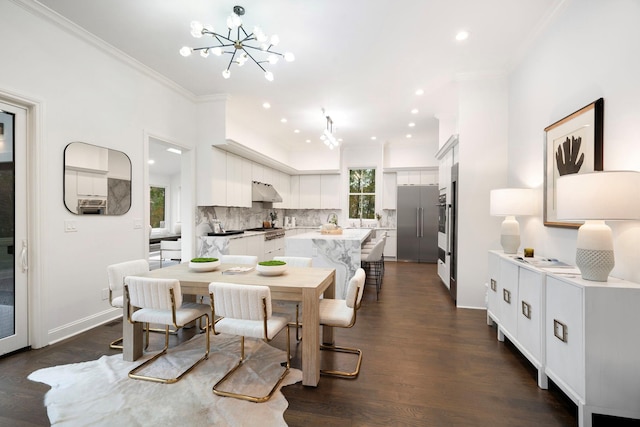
<box><xmin>398</xmin><ymin>185</ymin><xmax>440</xmax><ymax>263</ymax></box>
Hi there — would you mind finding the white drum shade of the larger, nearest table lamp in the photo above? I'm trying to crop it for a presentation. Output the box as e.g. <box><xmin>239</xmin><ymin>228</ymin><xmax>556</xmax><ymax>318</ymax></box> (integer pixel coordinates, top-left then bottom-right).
<box><xmin>556</xmin><ymin>171</ymin><xmax>640</xmax><ymax>220</ymax></box>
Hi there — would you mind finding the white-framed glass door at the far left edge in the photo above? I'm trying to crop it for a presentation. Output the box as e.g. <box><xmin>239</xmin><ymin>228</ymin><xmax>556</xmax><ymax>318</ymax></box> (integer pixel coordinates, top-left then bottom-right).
<box><xmin>0</xmin><ymin>102</ymin><xmax>29</xmax><ymax>355</ymax></box>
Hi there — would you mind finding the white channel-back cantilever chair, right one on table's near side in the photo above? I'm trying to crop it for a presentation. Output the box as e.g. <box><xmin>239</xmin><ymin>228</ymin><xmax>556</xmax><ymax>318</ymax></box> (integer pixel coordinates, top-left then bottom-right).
<box><xmin>209</xmin><ymin>282</ymin><xmax>290</xmax><ymax>403</ymax></box>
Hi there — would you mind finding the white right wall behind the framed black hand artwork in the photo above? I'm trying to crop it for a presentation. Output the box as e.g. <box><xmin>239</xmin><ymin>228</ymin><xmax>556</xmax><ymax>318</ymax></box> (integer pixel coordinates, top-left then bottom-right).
<box><xmin>510</xmin><ymin>0</ymin><xmax>640</xmax><ymax>282</ymax></box>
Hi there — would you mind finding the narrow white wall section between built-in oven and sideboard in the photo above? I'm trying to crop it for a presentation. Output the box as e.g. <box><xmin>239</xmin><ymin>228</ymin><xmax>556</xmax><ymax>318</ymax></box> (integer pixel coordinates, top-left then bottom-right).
<box><xmin>457</xmin><ymin>76</ymin><xmax>508</xmax><ymax>307</ymax></box>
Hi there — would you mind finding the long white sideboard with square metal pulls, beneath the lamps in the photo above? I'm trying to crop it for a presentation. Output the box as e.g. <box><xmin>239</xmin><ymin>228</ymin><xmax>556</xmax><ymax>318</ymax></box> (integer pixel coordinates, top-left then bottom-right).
<box><xmin>487</xmin><ymin>251</ymin><xmax>640</xmax><ymax>427</ymax></box>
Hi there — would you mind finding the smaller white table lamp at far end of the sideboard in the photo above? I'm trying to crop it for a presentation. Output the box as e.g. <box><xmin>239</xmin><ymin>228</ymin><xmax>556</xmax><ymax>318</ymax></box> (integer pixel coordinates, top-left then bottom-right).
<box><xmin>489</xmin><ymin>188</ymin><xmax>535</xmax><ymax>254</ymax></box>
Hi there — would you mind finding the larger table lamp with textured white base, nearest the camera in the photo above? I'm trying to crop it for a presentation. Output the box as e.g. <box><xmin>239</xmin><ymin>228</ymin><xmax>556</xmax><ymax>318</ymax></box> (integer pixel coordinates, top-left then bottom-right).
<box><xmin>556</xmin><ymin>171</ymin><xmax>640</xmax><ymax>282</ymax></box>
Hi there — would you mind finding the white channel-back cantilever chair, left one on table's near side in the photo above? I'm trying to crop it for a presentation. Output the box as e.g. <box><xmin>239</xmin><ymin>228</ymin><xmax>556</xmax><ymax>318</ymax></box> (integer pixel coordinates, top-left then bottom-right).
<box><xmin>124</xmin><ymin>276</ymin><xmax>211</xmax><ymax>384</ymax></box>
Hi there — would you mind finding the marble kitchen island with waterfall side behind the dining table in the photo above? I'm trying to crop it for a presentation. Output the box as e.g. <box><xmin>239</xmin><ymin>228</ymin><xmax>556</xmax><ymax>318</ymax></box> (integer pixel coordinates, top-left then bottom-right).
<box><xmin>284</xmin><ymin>229</ymin><xmax>373</xmax><ymax>298</ymax></box>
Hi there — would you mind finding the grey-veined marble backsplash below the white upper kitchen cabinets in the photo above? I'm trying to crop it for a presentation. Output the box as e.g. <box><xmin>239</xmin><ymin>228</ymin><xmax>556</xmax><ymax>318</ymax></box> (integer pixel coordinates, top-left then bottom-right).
<box><xmin>196</xmin><ymin>203</ymin><xmax>396</xmax><ymax>236</ymax></box>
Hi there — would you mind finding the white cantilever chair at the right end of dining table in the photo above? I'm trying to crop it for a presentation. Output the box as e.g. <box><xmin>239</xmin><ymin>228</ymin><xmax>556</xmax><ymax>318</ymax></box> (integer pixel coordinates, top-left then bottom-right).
<box><xmin>320</xmin><ymin>268</ymin><xmax>366</xmax><ymax>379</ymax></box>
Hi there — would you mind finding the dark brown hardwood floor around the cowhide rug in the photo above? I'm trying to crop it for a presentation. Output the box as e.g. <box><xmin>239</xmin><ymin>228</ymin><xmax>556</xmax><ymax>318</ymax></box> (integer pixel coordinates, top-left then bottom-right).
<box><xmin>0</xmin><ymin>262</ymin><xmax>639</xmax><ymax>427</ymax></box>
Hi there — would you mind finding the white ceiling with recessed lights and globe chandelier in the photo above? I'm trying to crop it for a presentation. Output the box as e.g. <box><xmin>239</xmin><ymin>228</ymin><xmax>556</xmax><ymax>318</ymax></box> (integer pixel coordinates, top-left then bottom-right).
<box><xmin>39</xmin><ymin>0</ymin><xmax>564</xmax><ymax>154</ymax></box>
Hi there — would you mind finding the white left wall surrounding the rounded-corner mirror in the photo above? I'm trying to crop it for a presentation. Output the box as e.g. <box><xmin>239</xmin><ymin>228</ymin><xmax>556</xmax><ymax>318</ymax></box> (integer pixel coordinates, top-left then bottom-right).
<box><xmin>0</xmin><ymin>1</ymin><xmax>196</xmax><ymax>347</ymax></box>
